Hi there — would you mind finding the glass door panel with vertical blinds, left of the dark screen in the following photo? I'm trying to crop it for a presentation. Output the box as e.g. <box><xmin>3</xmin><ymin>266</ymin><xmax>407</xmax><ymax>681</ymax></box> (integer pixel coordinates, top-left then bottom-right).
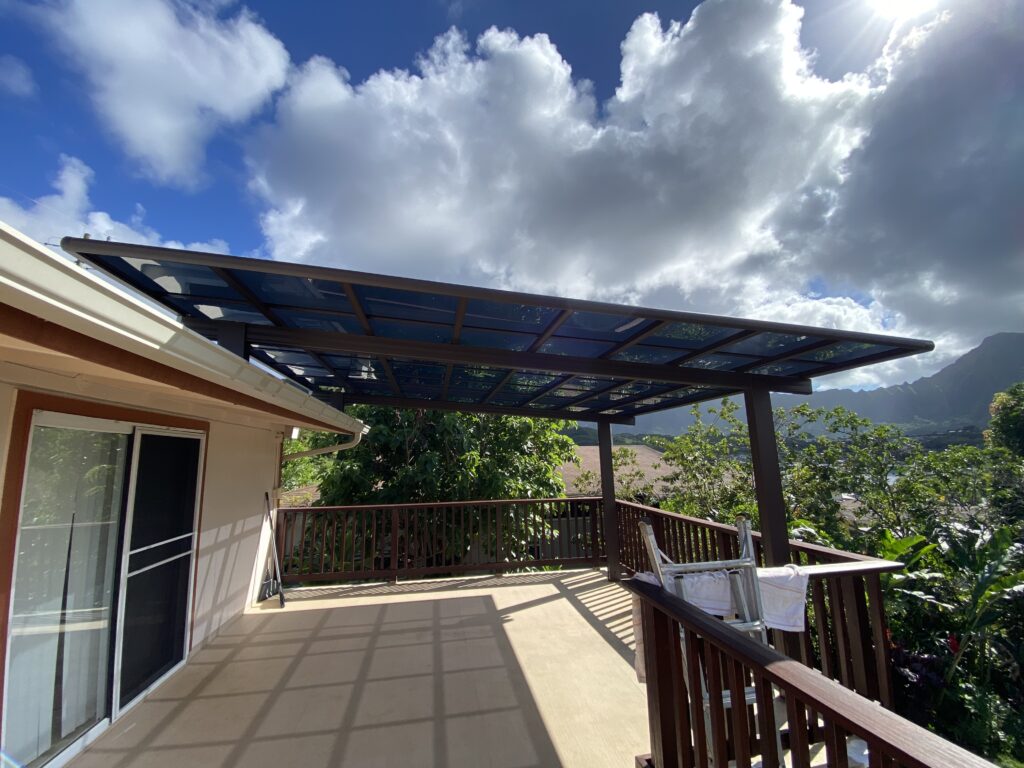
<box><xmin>3</xmin><ymin>415</ymin><xmax>131</xmax><ymax>765</ymax></box>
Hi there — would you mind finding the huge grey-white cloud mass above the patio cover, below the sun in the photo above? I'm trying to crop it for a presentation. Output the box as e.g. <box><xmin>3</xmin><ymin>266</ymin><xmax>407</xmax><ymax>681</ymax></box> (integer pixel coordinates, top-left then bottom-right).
<box><xmin>247</xmin><ymin>0</ymin><xmax>1024</xmax><ymax>385</ymax></box>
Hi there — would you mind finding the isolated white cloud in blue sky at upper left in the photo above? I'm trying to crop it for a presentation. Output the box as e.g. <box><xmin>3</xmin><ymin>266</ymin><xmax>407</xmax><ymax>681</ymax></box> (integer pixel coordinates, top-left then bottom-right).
<box><xmin>36</xmin><ymin>0</ymin><xmax>289</xmax><ymax>187</ymax></box>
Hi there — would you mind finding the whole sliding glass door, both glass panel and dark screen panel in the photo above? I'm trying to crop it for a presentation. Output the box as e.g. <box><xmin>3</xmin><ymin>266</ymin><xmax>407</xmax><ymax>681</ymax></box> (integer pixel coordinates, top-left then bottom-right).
<box><xmin>0</xmin><ymin>412</ymin><xmax>203</xmax><ymax>766</ymax></box>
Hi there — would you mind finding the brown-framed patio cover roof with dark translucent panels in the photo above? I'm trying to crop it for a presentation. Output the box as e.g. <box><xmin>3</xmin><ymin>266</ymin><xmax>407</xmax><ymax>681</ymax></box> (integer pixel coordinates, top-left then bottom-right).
<box><xmin>60</xmin><ymin>238</ymin><xmax>933</xmax><ymax>424</ymax></box>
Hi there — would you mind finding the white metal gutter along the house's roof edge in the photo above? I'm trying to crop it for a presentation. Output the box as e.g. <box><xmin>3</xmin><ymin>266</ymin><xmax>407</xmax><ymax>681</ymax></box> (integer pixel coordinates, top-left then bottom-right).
<box><xmin>0</xmin><ymin>221</ymin><xmax>365</xmax><ymax>444</ymax></box>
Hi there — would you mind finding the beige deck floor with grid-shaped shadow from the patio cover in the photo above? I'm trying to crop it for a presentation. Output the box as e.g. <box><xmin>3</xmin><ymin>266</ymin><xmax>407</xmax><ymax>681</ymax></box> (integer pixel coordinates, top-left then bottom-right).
<box><xmin>71</xmin><ymin>570</ymin><xmax>650</xmax><ymax>768</ymax></box>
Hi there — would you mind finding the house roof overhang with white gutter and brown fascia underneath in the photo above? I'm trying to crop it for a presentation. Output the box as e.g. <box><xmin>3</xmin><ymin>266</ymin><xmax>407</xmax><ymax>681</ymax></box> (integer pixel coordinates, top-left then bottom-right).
<box><xmin>0</xmin><ymin>222</ymin><xmax>364</xmax><ymax>437</ymax></box>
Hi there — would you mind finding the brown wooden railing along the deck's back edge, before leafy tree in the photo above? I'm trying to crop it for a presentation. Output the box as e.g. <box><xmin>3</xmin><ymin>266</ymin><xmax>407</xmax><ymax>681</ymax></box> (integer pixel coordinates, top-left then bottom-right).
<box><xmin>276</xmin><ymin>498</ymin><xmax>604</xmax><ymax>584</ymax></box>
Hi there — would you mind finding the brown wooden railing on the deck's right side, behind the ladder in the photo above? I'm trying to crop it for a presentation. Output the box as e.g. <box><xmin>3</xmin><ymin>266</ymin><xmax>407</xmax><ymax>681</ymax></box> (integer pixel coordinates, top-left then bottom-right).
<box><xmin>617</xmin><ymin>502</ymin><xmax>902</xmax><ymax>709</ymax></box>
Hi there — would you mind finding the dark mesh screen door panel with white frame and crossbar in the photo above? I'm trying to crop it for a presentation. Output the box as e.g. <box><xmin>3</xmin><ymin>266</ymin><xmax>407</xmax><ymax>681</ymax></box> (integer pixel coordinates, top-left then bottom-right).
<box><xmin>116</xmin><ymin>429</ymin><xmax>203</xmax><ymax>710</ymax></box>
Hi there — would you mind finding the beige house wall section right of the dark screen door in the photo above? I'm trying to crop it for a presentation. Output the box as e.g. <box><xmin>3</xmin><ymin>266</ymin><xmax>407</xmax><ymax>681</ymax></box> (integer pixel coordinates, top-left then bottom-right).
<box><xmin>193</xmin><ymin>422</ymin><xmax>282</xmax><ymax>646</ymax></box>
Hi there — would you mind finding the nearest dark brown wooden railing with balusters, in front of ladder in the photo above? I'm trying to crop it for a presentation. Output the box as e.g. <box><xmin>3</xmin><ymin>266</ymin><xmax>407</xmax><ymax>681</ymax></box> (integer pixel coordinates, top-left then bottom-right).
<box><xmin>624</xmin><ymin>579</ymin><xmax>991</xmax><ymax>768</ymax></box>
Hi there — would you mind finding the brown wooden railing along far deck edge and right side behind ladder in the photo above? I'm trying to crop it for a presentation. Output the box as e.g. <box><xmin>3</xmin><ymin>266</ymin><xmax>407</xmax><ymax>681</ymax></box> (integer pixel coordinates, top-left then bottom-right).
<box><xmin>276</xmin><ymin>497</ymin><xmax>900</xmax><ymax>720</ymax></box>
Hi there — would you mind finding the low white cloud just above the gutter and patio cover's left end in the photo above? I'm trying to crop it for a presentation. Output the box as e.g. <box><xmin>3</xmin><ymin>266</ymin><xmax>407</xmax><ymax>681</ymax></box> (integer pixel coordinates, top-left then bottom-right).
<box><xmin>0</xmin><ymin>155</ymin><xmax>228</xmax><ymax>253</ymax></box>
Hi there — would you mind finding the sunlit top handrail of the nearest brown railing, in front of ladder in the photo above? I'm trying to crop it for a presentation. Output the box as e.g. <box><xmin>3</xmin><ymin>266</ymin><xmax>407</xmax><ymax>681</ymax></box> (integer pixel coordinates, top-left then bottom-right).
<box><xmin>623</xmin><ymin>579</ymin><xmax>992</xmax><ymax>768</ymax></box>
